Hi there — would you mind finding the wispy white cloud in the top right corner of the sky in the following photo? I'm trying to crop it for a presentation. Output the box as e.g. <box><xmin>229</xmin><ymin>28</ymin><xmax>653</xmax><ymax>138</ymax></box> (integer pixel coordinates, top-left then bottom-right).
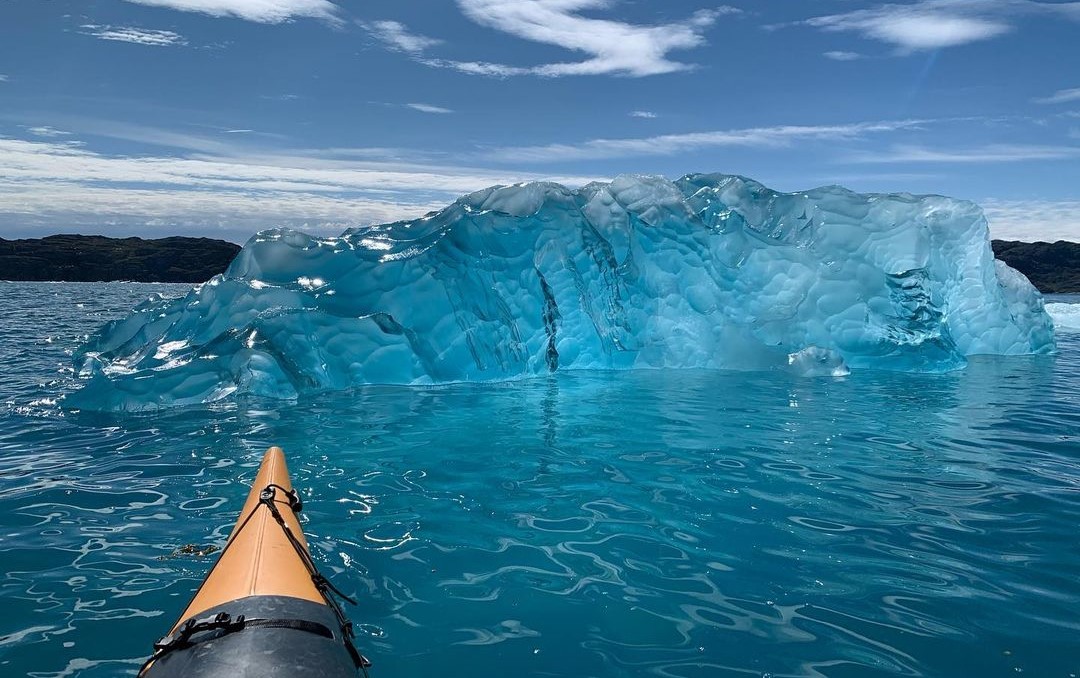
<box><xmin>802</xmin><ymin>0</ymin><xmax>1080</xmax><ymax>53</ymax></box>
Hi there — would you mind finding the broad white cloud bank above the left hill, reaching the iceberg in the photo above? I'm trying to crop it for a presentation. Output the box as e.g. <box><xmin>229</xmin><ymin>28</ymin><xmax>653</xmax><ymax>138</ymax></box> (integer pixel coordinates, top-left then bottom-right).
<box><xmin>0</xmin><ymin>138</ymin><xmax>596</xmax><ymax>240</ymax></box>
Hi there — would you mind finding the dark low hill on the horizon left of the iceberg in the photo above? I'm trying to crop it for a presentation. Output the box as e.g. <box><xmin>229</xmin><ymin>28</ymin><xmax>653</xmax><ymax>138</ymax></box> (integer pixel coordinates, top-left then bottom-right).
<box><xmin>0</xmin><ymin>235</ymin><xmax>240</xmax><ymax>283</ymax></box>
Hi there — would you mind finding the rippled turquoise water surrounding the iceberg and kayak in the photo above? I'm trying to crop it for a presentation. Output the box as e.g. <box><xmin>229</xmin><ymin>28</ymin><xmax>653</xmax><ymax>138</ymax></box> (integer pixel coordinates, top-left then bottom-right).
<box><xmin>0</xmin><ymin>283</ymin><xmax>1080</xmax><ymax>678</ymax></box>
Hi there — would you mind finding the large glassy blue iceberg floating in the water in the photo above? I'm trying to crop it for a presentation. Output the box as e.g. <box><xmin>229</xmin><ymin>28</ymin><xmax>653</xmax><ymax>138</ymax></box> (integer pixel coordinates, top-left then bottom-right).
<box><xmin>69</xmin><ymin>174</ymin><xmax>1054</xmax><ymax>410</ymax></box>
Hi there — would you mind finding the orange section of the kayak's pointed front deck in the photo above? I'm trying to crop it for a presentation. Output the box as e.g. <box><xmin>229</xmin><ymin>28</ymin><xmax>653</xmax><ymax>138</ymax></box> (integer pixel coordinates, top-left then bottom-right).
<box><xmin>174</xmin><ymin>447</ymin><xmax>325</xmax><ymax>628</ymax></box>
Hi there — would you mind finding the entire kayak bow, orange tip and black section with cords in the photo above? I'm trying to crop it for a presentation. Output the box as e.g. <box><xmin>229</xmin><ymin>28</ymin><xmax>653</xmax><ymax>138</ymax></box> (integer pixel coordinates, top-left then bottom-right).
<box><xmin>139</xmin><ymin>447</ymin><xmax>369</xmax><ymax>678</ymax></box>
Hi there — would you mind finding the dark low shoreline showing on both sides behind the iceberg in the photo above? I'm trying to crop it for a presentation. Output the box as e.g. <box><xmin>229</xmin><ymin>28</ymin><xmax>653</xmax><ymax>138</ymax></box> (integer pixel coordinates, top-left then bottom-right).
<box><xmin>0</xmin><ymin>235</ymin><xmax>1080</xmax><ymax>294</ymax></box>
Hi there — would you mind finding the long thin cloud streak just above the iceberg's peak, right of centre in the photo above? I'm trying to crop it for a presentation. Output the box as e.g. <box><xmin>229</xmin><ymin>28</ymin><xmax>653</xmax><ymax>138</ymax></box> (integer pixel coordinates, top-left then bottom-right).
<box><xmin>485</xmin><ymin>120</ymin><xmax>926</xmax><ymax>162</ymax></box>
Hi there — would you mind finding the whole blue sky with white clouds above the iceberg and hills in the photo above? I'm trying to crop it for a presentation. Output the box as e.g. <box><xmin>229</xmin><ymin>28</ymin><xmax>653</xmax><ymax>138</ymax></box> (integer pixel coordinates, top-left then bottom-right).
<box><xmin>0</xmin><ymin>0</ymin><xmax>1080</xmax><ymax>243</ymax></box>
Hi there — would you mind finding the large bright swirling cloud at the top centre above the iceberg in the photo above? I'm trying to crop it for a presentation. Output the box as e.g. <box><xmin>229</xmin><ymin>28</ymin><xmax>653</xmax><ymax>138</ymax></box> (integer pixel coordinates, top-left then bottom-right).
<box><xmin>365</xmin><ymin>0</ymin><xmax>741</xmax><ymax>78</ymax></box>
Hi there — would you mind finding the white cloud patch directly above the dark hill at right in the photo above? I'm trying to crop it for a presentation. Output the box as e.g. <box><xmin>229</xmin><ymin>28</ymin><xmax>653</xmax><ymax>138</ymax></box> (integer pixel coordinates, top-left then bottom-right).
<box><xmin>981</xmin><ymin>199</ymin><xmax>1080</xmax><ymax>243</ymax></box>
